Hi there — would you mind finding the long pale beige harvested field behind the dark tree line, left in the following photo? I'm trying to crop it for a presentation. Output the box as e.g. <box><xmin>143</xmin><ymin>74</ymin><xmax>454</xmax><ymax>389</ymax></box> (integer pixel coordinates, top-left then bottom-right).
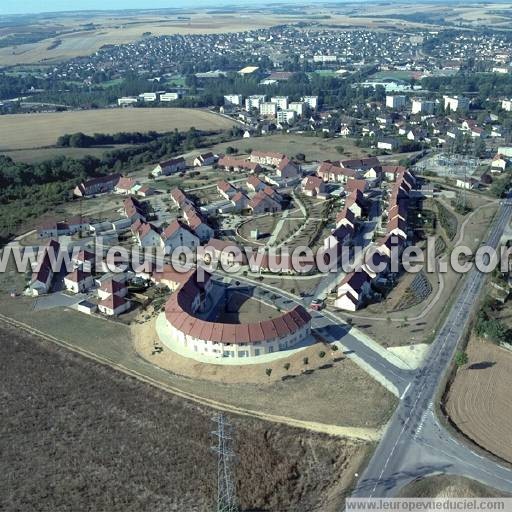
<box><xmin>0</xmin><ymin>108</ymin><xmax>234</xmax><ymax>151</ymax></box>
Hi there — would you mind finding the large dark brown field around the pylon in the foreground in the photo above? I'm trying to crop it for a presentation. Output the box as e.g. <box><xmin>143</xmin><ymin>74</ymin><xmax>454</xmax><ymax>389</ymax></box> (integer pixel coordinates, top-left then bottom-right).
<box><xmin>0</xmin><ymin>325</ymin><xmax>371</xmax><ymax>512</ymax></box>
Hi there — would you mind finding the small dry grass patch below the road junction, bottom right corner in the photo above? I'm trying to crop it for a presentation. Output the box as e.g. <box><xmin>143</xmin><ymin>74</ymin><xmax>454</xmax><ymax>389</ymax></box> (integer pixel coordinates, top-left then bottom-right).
<box><xmin>399</xmin><ymin>475</ymin><xmax>506</xmax><ymax>498</ymax></box>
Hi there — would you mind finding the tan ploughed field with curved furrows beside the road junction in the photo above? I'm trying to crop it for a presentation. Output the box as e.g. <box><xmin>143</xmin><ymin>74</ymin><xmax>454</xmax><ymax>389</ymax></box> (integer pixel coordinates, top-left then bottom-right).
<box><xmin>446</xmin><ymin>337</ymin><xmax>512</xmax><ymax>462</ymax></box>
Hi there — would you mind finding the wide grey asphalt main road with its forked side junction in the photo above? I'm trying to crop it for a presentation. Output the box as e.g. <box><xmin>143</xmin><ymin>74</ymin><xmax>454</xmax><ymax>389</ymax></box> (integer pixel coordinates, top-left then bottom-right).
<box><xmin>353</xmin><ymin>195</ymin><xmax>512</xmax><ymax>497</ymax></box>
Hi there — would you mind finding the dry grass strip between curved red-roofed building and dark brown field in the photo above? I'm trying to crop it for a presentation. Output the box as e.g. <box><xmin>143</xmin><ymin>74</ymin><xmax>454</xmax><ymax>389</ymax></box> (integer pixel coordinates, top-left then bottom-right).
<box><xmin>0</xmin><ymin>294</ymin><xmax>396</xmax><ymax>428</ymax></box>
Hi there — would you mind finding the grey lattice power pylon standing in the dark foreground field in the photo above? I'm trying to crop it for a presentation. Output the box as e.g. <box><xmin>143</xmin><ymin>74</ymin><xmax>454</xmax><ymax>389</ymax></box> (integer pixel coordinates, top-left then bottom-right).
<box><xmin>212</xmin><ymin>413</ymin><xmax>238</xmax><ymax>512</ymax></box>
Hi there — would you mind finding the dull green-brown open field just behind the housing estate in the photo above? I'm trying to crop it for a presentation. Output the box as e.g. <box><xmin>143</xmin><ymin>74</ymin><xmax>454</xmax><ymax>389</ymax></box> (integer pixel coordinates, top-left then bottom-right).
<box><xmin>212</xmin><ymin>134</ymin><xmax>368</xmax><ymax>161</ymax></box>
